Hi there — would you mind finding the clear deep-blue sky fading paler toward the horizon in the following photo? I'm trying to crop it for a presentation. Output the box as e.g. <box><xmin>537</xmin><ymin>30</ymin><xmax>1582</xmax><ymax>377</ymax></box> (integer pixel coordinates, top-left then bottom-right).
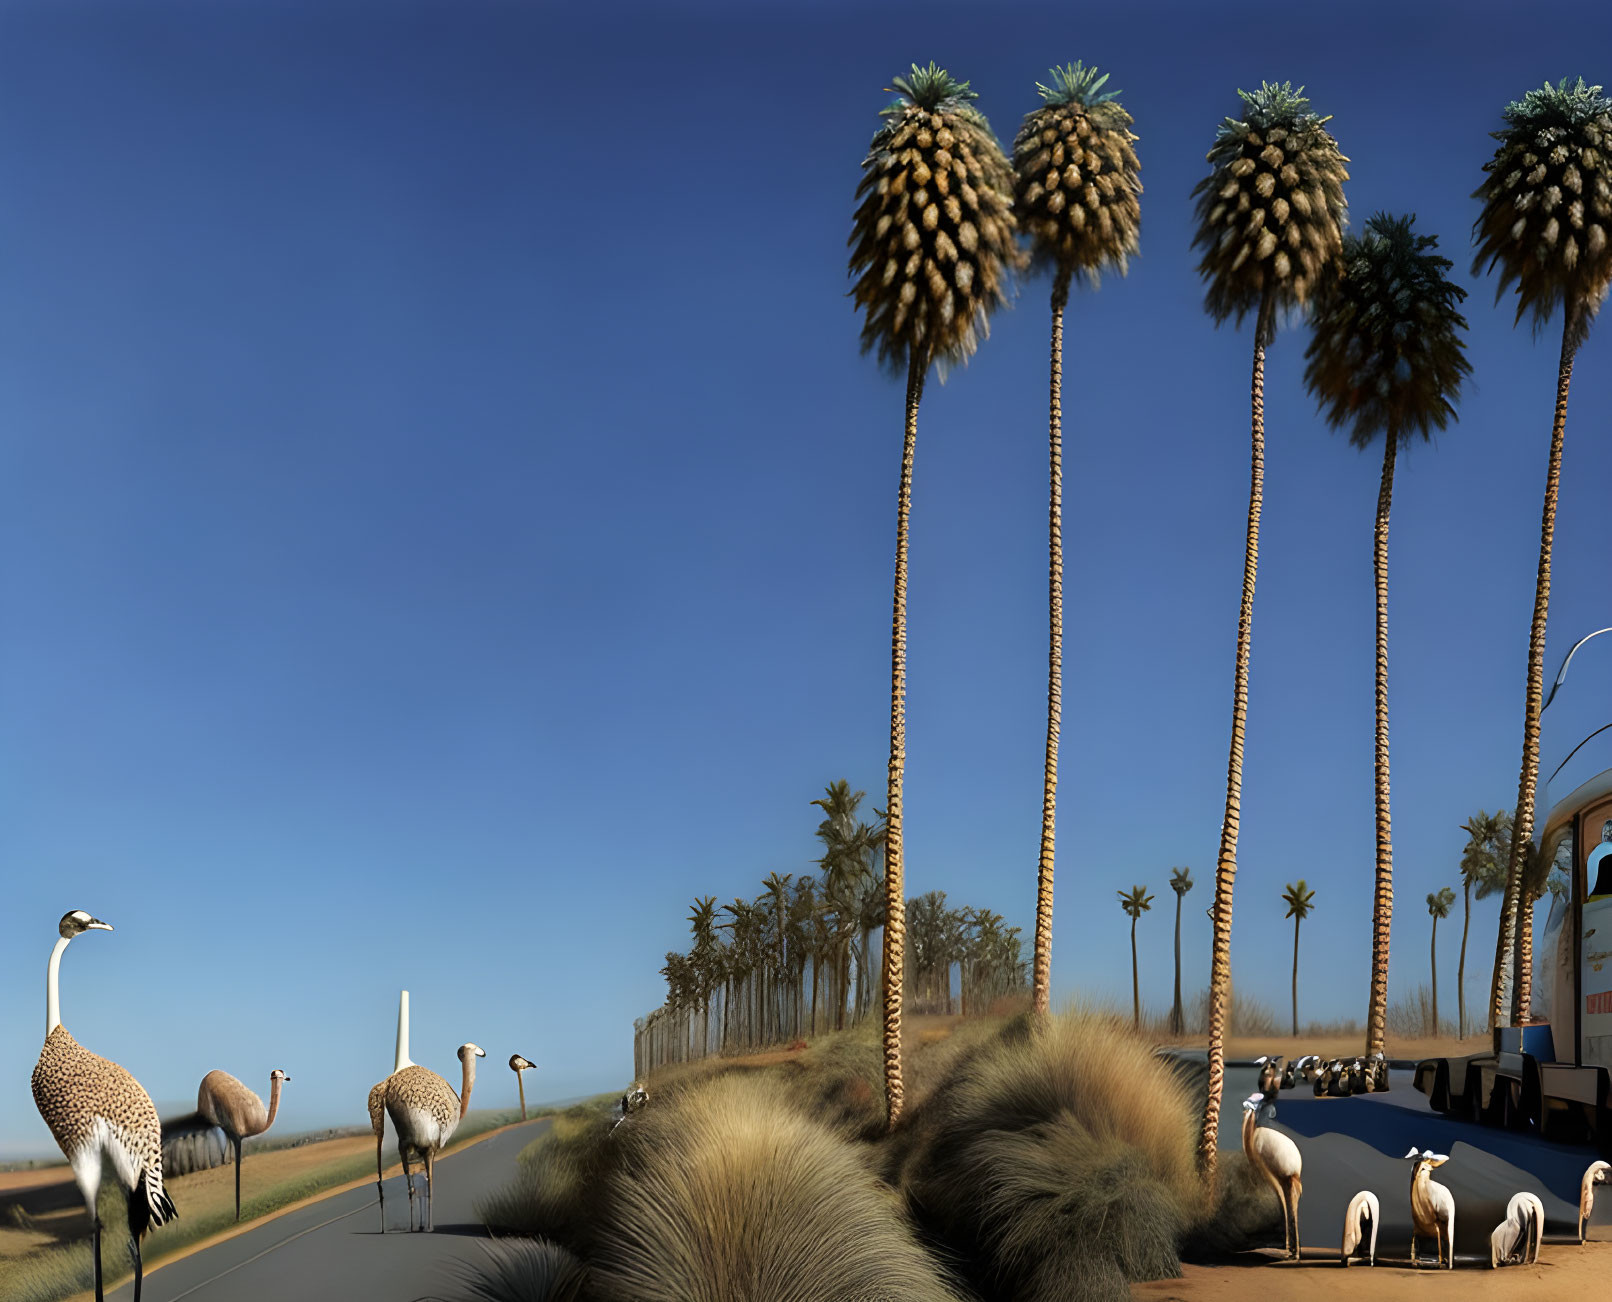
<box><xmin>0</xmin><ymin>0</ymin><xmax>1612</xmax><ymax>1152</ymax></box>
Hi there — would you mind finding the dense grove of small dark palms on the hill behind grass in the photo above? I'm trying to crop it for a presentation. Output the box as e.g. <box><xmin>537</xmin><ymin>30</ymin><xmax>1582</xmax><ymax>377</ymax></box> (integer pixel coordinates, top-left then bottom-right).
<box><xmin>634</xmin><ymin>780</ymin><xmax>1028</xmax><ymax>1075</ymax></box>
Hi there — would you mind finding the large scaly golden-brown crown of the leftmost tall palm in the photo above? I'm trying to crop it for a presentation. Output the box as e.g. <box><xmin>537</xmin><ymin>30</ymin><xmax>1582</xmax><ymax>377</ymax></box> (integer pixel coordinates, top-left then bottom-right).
<box><xmin>848</xmin><ymin>63</ymin><xmax>1025</xmax><ymax>371</ymax></box>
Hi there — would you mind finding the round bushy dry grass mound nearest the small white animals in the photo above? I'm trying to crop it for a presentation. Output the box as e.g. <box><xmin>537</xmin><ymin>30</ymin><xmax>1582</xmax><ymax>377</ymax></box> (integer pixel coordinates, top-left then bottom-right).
<box><xmin>890</xmin><ymin>1010</ymin><xmax>1199</xmax><ymax>1302</ymax></box>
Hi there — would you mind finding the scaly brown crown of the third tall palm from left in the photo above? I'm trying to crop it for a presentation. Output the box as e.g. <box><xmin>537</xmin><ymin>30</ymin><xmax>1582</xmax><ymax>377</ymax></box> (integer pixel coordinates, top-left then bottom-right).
<box><xmin>1193</xmin><ymin>82</ymin><xmax>1349</xmax><ymax>340</ymax></box>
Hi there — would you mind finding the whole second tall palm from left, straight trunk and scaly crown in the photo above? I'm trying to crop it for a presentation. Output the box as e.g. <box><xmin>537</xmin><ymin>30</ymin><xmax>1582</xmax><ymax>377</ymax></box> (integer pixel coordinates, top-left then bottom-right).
<box><xmin>1012</xmin><ymin>63</ymin><xmax>1141</xmax><ymax>1014</ymax></box>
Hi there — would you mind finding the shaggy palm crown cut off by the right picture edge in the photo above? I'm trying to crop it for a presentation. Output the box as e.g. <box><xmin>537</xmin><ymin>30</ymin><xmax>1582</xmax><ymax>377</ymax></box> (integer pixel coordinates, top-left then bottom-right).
<box><xmin>1472</xmin><ymin>77</ymin><xmax>1612</xmax><ymax>346</ymax></box>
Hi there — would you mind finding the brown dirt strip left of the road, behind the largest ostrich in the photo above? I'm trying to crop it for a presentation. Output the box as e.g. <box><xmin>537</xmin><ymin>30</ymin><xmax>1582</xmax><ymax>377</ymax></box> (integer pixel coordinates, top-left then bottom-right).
<box><xmin>0</xmin><ymin>1136</ymin><xmax>376</xmax><ymax>1260</ymax></box>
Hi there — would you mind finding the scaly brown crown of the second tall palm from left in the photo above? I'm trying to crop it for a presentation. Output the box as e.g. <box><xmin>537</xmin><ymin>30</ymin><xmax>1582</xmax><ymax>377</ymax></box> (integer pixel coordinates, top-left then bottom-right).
<box><xmin>1012</xmin><ymin>63</ymin><xmax>1141</xmax><ymax>284</ymax></box>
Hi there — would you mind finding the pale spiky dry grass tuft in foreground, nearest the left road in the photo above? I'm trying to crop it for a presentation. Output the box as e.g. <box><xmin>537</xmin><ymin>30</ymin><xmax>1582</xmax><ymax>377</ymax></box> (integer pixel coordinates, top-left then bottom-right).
<box><xmin>592</xmin><ymin>1075</ymin><xmax>958</xmax><ymax>1302</ymax></box>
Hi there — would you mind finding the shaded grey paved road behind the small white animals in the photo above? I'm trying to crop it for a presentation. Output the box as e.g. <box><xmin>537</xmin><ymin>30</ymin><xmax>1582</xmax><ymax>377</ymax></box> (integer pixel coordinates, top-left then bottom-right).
<box><xmin>1182</xmin><ymin>1054</ymin><xmax>1612</xmax><ymax>1263</ymax></box>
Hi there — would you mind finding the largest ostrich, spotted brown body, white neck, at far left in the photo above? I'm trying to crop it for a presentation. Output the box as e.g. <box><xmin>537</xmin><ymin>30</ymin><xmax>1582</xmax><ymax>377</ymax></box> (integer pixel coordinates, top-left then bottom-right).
<box><xmin>34</xmin><ymin>909</ymin><xmax>179</xmax><ymax>1302</ymax></box>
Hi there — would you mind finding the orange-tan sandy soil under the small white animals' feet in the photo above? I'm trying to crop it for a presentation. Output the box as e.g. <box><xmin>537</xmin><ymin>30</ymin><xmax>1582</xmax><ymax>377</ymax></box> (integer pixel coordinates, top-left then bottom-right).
<box><xmin>1130</xmin><ymin>1242</ymin><xmax>1612</xmax><ymax>1302</ymax></box>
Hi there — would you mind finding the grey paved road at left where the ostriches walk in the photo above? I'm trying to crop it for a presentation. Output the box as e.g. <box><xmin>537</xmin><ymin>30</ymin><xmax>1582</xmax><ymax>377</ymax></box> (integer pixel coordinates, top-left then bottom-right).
<box><xmin>112</xmin><ymin>1120</ymin><xmax>548</xmax><ymax>1302</ymax></box>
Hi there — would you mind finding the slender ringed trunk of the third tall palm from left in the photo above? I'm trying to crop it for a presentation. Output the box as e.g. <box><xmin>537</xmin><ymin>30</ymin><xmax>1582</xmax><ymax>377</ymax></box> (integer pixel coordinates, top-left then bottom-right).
<box><xmin>1198</xmin><ymin>292</ymin><xmax>1275</xmax><ymax>1191</ymax></box>
